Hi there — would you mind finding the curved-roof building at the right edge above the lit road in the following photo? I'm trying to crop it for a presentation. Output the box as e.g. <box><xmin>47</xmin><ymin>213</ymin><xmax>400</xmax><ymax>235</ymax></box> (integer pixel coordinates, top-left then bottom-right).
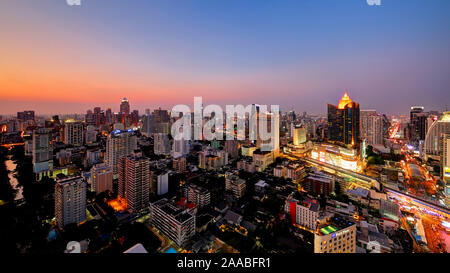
<box><xmin>424</xmin><ymin>112</ymin><xmax>450</xmax><ymax>161</ymax></box>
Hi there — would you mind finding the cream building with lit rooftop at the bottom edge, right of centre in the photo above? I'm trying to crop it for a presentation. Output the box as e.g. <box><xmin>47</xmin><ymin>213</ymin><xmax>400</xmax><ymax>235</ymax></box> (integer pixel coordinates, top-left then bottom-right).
<box><xmin>314</xmin><ymin>216</ymin><xmax>356</xmax><ymax>253</ymax></box>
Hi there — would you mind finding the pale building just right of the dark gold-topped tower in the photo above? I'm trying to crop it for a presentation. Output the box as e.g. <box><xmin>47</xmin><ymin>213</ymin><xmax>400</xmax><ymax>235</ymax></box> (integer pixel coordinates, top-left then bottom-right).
<box><xmin>360</xmin><ymin>110</ymin><xmax>383</xmax><ymax>145</ymax></box>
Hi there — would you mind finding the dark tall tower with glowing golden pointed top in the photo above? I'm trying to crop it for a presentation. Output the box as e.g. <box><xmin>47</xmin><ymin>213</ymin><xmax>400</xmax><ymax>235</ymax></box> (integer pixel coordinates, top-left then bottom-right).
<box><xmin>328</xmin><ymin>92</ymin><xmax>360</xmax><ymax>146</ymax></box>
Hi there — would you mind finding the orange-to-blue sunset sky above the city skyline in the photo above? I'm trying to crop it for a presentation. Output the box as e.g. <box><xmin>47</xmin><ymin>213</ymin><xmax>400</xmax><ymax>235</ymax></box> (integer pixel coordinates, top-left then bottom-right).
<box><xmin>0</xmin><ymin>0</ymin><xmax>450</xmax><ymax>115</ymax></box>
